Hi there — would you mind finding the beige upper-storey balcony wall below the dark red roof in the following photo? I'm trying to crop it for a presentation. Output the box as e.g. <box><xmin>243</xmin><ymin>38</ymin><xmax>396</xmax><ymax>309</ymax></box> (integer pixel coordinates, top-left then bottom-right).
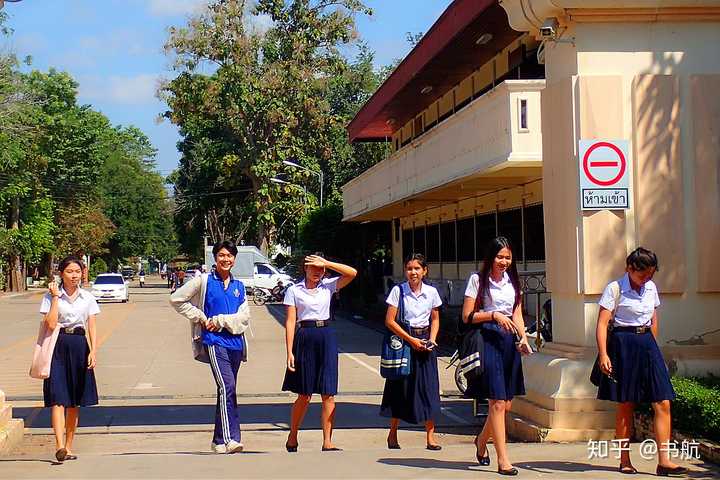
<box><xmin>343</xmin><ymin>80</ymin><xmax>544</xmax><ymax>219</ymax></box>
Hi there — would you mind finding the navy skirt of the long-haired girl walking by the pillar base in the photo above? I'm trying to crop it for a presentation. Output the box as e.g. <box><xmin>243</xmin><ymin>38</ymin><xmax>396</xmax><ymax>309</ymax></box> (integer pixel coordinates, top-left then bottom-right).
<box><xmin>465</xmin><ymin>322</ymin><xmax>525</xmax><ymax>400</ymax></box>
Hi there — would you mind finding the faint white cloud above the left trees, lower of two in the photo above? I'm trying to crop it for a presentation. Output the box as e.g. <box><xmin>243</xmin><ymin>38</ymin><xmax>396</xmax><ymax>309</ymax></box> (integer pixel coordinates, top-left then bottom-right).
<box><xmin>78</xmin><ymin>73</ymin><xmax>160</xmax><ymax>105</ymax></box>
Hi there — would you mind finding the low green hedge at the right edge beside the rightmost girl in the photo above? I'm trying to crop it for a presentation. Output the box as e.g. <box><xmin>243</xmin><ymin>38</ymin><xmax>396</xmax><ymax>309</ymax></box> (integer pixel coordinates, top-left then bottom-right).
<box><xmin>672</xmin><ymin>377</ymin><xmax>720</xmax><ymax>442</ymax></box>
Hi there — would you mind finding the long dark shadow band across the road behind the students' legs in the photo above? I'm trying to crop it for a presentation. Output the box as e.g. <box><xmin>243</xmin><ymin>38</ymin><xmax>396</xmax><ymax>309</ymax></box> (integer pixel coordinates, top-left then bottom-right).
<box><xmin>13</xmin><ymin>396</ymin><xmax>472</xmax><ymax>431</ymax></box>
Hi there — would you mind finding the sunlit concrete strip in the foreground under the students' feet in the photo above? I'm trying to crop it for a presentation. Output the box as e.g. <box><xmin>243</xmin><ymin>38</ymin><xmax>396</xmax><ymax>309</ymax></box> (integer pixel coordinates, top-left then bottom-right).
<box><xmin>0</xmin><ymin>429</ymin><xmax>720</xmax><ymax>479</ymax></box>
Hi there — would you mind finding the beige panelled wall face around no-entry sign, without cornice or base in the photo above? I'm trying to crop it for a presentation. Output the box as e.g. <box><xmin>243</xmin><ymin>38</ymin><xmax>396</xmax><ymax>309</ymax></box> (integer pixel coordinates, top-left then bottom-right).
<box><xmin>542</xmin><ymin>23</ymin><xmax>720</xmax><ymax>346</ymax></box>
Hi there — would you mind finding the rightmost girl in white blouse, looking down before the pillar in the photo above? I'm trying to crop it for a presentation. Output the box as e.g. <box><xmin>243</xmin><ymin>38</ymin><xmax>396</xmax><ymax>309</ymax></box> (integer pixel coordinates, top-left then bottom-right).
<box><xmin>596</xmin><ymin>247</ymin><xmax>688</xmax><ymax>476</ymax></box>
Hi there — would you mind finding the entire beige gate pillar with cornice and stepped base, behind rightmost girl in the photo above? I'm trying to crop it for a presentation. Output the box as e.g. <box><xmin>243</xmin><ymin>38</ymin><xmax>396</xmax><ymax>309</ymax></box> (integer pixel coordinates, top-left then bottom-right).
<box><xmin>502</xmin><ymin>0</ymin><xmax>720</xmax><ymax>441</ymax></box>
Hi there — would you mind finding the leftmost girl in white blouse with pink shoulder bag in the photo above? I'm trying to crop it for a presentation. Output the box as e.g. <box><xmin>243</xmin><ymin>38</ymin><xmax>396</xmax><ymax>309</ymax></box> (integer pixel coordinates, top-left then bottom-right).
<box><xmin>40</xmin><ymin>256</ymin><xmax>100</xmax><ymax>462</ymax></box>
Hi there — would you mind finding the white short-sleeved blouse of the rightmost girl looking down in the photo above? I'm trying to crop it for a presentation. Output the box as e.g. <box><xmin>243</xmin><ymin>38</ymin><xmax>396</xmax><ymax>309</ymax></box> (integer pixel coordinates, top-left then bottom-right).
<box><xmin>598</xmin><ymin>273</ymin><xmax>660</xmax><ymax>327</ymax></box>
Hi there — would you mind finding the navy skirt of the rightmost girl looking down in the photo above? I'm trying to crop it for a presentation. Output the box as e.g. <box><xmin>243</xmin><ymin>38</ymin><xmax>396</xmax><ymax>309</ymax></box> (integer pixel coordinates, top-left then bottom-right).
<box><xmin>597</xmin><ymin>331</ymin><xmax>675</xmax><ymax>403</ymax></box>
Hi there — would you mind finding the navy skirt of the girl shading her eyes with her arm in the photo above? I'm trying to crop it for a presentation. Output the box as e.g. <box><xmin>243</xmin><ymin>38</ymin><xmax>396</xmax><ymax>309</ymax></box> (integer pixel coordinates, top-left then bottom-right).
<box><xmin>282</xmin><ymin>327</ymin><xmax>338</xmax><ymax>395</ymax></box>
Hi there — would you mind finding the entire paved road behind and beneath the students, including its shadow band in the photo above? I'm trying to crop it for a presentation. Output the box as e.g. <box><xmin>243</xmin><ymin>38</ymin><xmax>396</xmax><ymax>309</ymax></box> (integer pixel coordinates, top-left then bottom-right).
<box><xmin>0</xmin><ymin>279</ymin><xmax>717</xmax><ymax>478</ymax></box>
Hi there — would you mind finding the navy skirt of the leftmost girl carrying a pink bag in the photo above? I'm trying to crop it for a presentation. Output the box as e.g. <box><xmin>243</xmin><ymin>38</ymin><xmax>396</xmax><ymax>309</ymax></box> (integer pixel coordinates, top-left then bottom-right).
<box><xmin>43</xmin><ymin>333</ymin><xmax>98</xmax><ymax>407</ymax></box>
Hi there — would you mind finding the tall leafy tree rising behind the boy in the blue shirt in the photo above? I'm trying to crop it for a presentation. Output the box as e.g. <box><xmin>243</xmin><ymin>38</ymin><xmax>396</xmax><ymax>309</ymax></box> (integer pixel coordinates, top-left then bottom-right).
<box><xmin>162</xmin><ymin>0</ymin><xmax>370</xmax><ymax>253</ymax></box>
